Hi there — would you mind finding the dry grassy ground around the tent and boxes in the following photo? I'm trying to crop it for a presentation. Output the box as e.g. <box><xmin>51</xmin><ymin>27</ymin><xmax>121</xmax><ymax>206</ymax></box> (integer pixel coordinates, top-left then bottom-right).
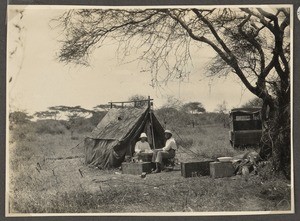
<box><xmin>9</xmin><ymin>123</ymin><xmax>290</xmax><ymax>213</ymax></box>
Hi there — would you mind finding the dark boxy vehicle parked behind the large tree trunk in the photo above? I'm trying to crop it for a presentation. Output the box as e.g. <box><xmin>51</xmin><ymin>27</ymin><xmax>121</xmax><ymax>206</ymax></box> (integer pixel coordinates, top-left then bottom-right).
<box><xmin>229</xmin><ymin>108</ymin><xmax>262</xmax><ymax>148</ymax></box>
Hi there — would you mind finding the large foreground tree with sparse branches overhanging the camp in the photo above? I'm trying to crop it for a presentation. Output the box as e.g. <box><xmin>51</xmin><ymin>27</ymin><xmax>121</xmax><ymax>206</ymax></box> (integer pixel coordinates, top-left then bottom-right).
<box><xmin>57</xmin><ymin>7</ymin><xmax>290</xmax><ymax>178</ymax></box>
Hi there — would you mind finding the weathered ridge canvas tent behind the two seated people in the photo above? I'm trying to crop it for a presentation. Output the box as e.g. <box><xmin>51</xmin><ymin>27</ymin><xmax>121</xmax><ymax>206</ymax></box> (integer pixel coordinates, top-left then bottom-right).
<box><xmin>84</xmin><ymin>108</ymin><xmax>165</xmax><ymax>168</ymax></box>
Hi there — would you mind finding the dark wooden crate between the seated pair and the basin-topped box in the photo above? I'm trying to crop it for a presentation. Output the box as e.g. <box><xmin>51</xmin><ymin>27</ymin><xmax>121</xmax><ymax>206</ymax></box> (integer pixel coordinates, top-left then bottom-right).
<box><xmin>180</xmin><ymin>160</ymin><xmax>213</xmax><ymax>178</ymax></box>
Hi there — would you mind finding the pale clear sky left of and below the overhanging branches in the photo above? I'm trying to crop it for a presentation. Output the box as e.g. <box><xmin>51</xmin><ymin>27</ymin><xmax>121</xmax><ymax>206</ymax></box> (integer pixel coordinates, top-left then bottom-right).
<box><xmin>7</xmin><ymin>6</ymin><xmax>254</xmax><ymax>114</ymax></box>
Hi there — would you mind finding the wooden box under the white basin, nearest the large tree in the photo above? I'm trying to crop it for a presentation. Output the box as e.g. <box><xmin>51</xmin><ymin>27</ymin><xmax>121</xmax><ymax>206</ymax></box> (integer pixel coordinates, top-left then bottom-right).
<box><xmin>209</xmin><ymin>162</ymin><xmax>235</xmax><ymax>178</ymax></box>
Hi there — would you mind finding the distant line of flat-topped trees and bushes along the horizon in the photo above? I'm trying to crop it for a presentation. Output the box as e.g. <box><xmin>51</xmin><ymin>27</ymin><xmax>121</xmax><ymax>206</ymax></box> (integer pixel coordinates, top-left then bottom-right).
<box><xmin>9</xmin><ymin>95</ymin><xmax>261</xmax><ymax>138</ymax></box>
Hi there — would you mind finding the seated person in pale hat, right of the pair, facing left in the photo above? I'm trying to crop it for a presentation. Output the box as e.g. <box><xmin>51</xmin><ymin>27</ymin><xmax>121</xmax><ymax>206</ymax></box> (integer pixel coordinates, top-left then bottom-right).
<box><xmin>152</xmin><ymin>130</ymin><xmax>177</xmax><ymax>173</ymax></box>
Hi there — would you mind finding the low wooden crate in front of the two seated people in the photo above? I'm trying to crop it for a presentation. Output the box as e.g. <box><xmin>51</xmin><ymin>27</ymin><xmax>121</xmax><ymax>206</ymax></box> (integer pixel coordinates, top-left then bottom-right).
<box><xmin>122</xmin><ymin>162</ymin><xmax>152</xmax><ymax>175</ymax></box>
